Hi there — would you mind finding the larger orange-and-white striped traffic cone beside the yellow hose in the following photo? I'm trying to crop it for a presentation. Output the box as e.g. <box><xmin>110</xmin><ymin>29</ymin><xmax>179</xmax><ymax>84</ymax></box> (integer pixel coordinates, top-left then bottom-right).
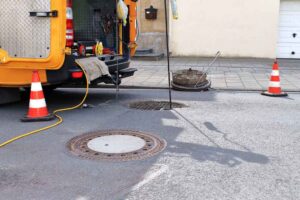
<box><xmin>21</xmin><ymin>71</ymin><xmax>54</xmax><ymax>122</ymax></box>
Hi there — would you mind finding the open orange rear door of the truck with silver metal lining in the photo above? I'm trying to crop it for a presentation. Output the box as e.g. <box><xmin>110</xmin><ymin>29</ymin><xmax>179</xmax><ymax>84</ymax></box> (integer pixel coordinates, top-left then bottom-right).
<box><xmin>0</xmin><ymin>0</ymin><xmax>66</xmax><ymax>69</ymax></box>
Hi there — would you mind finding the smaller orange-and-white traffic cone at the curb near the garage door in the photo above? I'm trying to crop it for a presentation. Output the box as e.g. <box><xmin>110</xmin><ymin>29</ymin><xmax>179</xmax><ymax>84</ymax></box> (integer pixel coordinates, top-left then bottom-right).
<box><xmin>262</xmin><ymin>60</ymin><xmax>287</xmax><ymax>97</ymax></box>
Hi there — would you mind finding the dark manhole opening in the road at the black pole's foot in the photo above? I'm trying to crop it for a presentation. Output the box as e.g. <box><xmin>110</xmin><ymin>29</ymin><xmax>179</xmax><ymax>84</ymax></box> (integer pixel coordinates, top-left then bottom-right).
<box><xmin>129</xmin><ymin>101</ymin><xmax>187</xmax><ymax>110</ymax></box>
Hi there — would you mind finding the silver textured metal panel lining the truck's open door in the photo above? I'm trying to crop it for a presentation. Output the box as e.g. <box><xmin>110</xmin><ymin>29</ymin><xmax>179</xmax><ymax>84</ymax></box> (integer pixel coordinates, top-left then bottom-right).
<box><xmin>0</xmin><ymin>0</ymin><xmax>50</xmax><ymax>58</ymax></box>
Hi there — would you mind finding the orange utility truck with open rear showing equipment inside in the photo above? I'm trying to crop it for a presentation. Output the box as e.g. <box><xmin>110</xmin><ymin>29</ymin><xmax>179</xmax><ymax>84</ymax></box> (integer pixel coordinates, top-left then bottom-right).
<box><xmin>0</xmin><ymin>0</ymin><xmax>138</xmax><ymax>103</ymax></box>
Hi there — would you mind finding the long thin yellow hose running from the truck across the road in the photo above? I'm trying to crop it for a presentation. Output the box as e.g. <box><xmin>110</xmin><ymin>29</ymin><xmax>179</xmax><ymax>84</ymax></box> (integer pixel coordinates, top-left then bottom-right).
<box><xmin>0</xmin><ymin>63</ymin><xmax>89</xmax><ymax>148</ymax></box>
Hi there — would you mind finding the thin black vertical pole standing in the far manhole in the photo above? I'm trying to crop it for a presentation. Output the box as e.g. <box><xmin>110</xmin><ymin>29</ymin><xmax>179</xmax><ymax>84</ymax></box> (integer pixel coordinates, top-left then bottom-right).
<box><xmin>165</xmin><ymin>0</ymin><xmax>173</xmax><ymax>110</ymax></box>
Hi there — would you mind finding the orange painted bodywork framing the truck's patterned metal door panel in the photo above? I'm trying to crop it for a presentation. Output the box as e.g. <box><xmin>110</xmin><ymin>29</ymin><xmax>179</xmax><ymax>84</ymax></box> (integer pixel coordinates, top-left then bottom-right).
<box><xmin>0</xmin><ymin>0</ymin><xmax>66</xmax><ymax>87</ymax></box>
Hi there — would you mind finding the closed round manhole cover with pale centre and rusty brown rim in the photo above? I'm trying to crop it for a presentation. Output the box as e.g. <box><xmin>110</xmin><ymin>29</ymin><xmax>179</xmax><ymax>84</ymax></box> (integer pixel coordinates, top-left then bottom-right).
<box><xmin>67</xmin><ymin>130</ymin><xmax>166</xmax><ymax>161</ymax></box>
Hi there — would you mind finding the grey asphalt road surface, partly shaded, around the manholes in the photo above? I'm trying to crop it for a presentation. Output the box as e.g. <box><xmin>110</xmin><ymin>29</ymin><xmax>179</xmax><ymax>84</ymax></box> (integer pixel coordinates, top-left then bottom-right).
<box><xmin>0</xmin><ymin>89</ymin><xmax>300</xmax><ymax>200</ymax></box>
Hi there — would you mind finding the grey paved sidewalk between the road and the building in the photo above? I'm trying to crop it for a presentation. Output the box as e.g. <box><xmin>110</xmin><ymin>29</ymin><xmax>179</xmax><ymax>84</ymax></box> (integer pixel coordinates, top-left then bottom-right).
<box><xmin>122</xmin><ymin>58</ymin><xmax>300</xmax><ymax>92</ymax></box>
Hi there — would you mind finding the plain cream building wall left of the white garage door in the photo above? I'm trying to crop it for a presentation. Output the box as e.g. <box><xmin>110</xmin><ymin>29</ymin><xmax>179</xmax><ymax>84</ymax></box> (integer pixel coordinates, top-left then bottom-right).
<box><xmin>170</xmin><ymin>0</ymin><xmax>280</xmax><ymax>58</ymax></box>
